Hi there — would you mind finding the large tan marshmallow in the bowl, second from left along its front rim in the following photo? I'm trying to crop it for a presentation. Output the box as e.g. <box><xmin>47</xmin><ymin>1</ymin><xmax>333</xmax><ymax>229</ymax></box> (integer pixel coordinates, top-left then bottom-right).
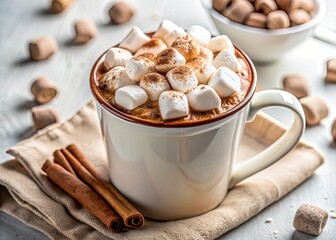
<box><xmin>223</xmin><ymin>1</ymin><xmax>254</xmax><ymax>23</ymax></box>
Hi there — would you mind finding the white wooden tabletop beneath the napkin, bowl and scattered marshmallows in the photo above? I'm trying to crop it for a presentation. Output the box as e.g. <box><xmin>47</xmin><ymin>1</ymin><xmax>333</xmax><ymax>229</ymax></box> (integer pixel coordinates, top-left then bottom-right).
<box><xmin>0</xmin><ymin>0</ymin><xmax>336</xmax><ymax>239</ymax></box>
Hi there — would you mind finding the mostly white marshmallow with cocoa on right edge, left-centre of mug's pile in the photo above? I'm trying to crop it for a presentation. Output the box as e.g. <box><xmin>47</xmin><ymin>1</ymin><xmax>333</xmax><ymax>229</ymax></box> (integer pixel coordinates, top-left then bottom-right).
<box><xmin>125</xmin><ymin>57</ymin><xmax>155</xmax><ymax>82</ymax></box>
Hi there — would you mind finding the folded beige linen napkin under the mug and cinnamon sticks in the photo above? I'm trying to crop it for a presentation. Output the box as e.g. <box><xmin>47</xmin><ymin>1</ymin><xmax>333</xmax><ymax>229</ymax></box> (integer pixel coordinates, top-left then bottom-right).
<box><xmin>0</xmin><ymin>102</ymin><xmax>324</xmax><ymax>239</ymax></box>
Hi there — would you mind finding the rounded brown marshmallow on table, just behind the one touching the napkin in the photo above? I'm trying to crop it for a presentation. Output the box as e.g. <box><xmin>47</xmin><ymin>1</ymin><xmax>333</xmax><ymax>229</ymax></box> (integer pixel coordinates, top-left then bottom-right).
<box><xmin>31</xmin><ymin>77</ymin><xmax>58</xmax><ymax>104</ymax></box>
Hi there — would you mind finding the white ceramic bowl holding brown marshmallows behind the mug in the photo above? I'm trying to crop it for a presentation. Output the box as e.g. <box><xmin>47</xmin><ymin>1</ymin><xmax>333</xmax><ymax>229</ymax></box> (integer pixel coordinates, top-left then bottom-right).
<box><xmin>202</xmin><ymin>0</ymin><xmax>326</xmax><ymax>62</ymax></box>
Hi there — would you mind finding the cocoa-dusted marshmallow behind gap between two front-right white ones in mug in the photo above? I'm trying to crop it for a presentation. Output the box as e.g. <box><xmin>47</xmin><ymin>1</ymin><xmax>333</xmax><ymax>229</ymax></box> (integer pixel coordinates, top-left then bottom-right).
<box><xmin>166</xmin><ymin>66</ymin><xmax>198</xmax><ymax>93</ymax></box>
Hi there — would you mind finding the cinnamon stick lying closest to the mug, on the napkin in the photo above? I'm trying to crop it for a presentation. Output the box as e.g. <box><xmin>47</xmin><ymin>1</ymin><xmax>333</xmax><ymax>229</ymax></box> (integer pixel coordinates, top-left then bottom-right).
<box><xmin>66</xmin><ymin>144</ymin><xmax>145</xmax><ymax>228</ymax></box>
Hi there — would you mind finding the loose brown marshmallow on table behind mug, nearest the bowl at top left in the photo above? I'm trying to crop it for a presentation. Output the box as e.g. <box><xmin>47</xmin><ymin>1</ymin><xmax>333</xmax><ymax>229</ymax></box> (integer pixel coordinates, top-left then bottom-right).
<box><xmin>109</xmin><ymin>2</ymin><xmax>134</xmax><ymax>25</ymax></box>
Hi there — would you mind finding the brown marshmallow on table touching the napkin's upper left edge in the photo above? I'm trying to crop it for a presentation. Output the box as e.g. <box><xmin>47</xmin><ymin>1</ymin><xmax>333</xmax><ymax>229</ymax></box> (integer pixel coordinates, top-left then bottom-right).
<box><xmin>32</xmin><ymin>107</ymin><xmax>60</xmax><ymax>130</ymax></box>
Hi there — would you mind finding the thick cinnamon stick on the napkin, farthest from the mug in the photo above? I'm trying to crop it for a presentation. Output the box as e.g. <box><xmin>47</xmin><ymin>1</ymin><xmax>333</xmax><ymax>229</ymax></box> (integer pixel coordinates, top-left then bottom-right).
<box><xmin>42</xmin><ymin>160</ymin><xmax>123</xmax><ymax>232</ymax></box>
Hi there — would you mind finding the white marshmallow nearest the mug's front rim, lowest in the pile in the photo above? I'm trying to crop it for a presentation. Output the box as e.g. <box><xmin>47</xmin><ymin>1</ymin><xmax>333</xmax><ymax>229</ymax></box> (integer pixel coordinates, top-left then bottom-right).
<box><xmin>159</xmin><ymin>90</ymin><xmax>189</xmax><ymax>120</ymax></box>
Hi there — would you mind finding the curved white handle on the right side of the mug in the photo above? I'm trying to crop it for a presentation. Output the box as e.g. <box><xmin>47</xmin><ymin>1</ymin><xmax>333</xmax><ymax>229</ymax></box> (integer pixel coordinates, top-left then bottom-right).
<box><xmin>229</xmin><ymin>90</ymin><xmax>306</xmax><ymax>188</ymax></box>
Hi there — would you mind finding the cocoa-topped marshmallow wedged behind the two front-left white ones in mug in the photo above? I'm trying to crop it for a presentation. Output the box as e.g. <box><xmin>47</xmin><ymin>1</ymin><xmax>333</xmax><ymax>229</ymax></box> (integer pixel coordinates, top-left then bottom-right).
<box><xmin>139</xmin><ymin>73</ymin><xmax>170</xmax><ymax>101</ymax></box>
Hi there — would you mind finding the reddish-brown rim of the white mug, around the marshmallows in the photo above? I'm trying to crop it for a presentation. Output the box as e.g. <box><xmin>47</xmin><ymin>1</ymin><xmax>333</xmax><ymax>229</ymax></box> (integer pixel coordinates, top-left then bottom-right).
<box><xmin>90</xmin><ymin>32</ymin><xmax>257</xmax><ymax>128</ymax></box>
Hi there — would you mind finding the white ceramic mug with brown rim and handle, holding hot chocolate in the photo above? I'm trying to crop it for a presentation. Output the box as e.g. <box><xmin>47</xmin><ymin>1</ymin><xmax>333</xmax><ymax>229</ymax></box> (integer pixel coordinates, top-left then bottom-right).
<box><xmin>90</xmin><ymin>45</ymin><xmax>305</xmax><ymax>220</ymax></box>
